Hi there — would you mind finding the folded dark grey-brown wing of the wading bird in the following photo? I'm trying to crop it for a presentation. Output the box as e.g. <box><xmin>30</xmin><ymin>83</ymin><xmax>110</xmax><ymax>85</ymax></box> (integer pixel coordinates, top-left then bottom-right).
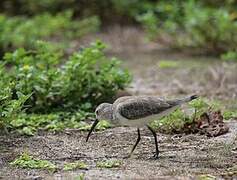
<box><xmin>117</xmin><ymin>97</ymin><xmax>174</xmax><ymax>120</ymax></box>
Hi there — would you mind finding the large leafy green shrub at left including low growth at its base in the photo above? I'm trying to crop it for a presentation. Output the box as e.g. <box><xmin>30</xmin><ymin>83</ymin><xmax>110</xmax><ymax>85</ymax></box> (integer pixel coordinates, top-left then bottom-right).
<box><xmin>0</xmin><ymin>41</ymin><xmax>131</xmax><ymax>135</ymax></box>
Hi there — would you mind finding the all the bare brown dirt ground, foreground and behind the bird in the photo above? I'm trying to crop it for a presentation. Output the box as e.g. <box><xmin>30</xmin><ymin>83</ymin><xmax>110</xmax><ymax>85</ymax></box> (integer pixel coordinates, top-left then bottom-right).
<box><xmin>0</xmin><ymin>28</ymin><xmax>237</xmax><ymax>179</ymax></box>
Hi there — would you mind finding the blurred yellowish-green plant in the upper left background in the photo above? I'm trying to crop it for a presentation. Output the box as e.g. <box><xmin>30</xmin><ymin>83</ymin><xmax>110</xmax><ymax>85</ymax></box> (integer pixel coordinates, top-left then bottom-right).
<box><xmin>0</xmin><ymin>11</ymin><xmax>100</xmax><ymax>52</ymax></box>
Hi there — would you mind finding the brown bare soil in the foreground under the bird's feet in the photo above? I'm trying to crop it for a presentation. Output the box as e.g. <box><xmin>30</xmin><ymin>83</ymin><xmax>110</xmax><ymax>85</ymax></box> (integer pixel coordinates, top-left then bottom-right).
<box><xmin>0</xmin><ymin>122</ymin><xmax>237</xmax><ymax>179</ymax></box>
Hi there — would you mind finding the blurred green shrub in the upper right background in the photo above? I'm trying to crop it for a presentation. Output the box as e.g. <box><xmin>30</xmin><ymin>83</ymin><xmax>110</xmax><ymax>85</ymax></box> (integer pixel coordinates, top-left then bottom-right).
<box><xmin>138</xmin><ymin>0</ymin><xmax>237</xmax><ymax>54</ymax></box>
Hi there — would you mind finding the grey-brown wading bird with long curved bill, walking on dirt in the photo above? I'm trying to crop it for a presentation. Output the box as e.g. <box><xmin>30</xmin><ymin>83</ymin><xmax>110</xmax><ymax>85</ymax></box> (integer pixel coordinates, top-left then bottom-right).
<box><xmin>86</xmin><ymin>95</ymin><xmax>198</xmax><ymax>158</ymax></box>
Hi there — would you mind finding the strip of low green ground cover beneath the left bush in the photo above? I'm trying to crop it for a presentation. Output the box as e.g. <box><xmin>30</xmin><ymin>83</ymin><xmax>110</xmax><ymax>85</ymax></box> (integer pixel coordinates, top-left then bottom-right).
<box><xmin>10</xmin><ymin>111</ymin><xmax>94</xmax><ymax>136</ymax></box>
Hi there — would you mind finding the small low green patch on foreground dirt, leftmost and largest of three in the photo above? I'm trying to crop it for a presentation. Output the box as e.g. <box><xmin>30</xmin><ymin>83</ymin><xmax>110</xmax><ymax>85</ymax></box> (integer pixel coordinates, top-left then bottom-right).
<box><xmin>10</xmin><ymin>153</ymin><xmax>57</xmax><ymax>172</ymax></box>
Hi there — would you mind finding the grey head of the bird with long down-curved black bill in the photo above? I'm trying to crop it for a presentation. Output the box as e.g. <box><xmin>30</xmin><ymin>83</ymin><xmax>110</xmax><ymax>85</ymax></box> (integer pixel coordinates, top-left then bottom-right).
<box><xmin>86</xmin><ymin>103</ymin><xmax>113</xmax><ymax>142</ymax></box>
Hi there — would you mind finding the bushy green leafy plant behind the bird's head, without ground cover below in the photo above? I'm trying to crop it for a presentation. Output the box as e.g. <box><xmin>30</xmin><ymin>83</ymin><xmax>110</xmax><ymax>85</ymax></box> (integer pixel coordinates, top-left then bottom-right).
<box><xmin>4</xmin><ymin>42</ymin><xmax>130</xmax><ymax>112</ymax></box>
